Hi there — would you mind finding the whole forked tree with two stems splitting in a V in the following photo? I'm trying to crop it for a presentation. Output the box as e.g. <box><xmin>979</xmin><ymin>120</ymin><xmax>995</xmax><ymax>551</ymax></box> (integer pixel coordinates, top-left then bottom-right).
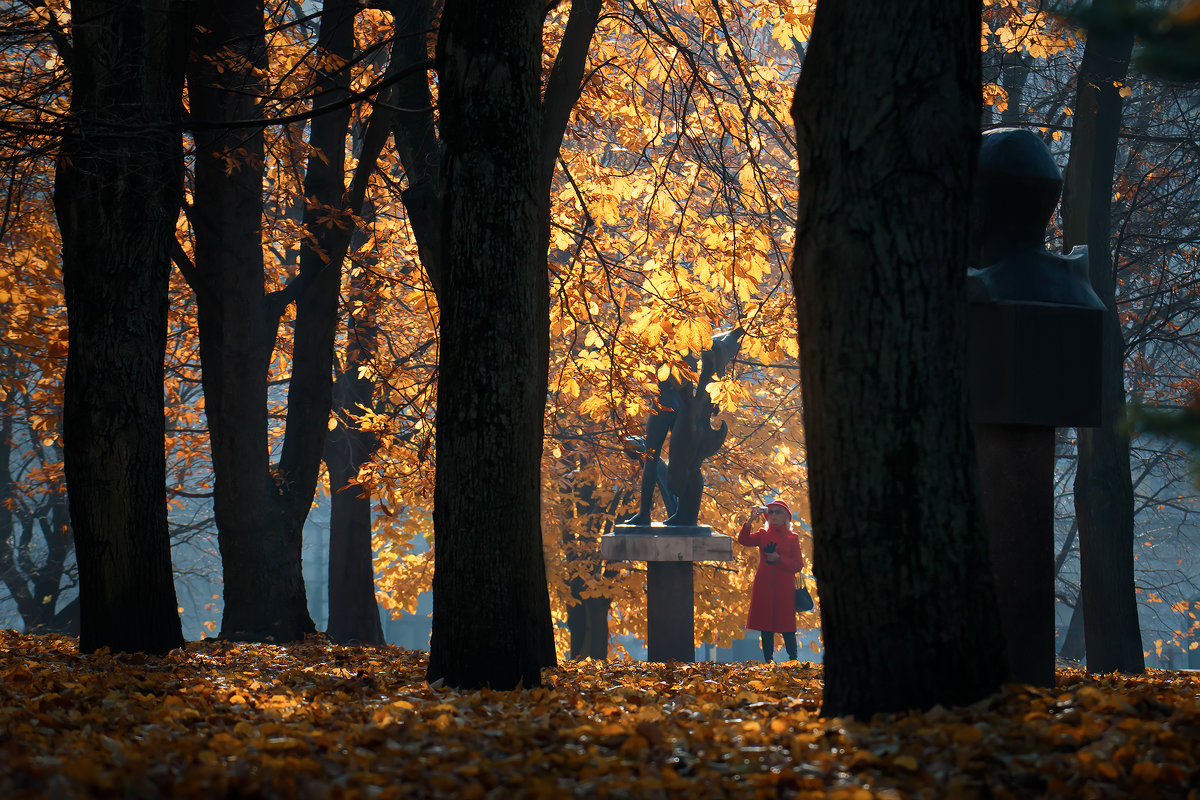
<box><xmin>188</xmin><ymin>0</ymin><xmax>378</xmax><ymax>642</ymax></box>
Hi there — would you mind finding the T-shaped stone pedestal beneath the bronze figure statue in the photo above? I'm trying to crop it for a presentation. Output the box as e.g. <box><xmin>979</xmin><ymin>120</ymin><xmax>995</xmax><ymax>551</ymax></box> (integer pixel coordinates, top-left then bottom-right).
<box><xmin>600</xmin><ymin>523</ymin><xmax>733</xmax><ymax>662</ymax></box>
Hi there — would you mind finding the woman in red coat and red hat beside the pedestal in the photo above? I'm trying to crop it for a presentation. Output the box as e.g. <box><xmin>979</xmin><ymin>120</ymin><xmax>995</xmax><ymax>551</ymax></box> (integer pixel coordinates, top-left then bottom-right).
<box><xmin>738</xmin><ymin>500</ymin><xmax>804</xmax><ymax>662</ymax></box>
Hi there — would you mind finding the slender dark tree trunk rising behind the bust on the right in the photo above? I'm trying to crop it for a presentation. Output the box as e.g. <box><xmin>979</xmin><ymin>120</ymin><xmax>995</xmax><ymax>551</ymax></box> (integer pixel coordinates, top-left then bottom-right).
<box><xmin>1062</xmin><ymin>12</ymin><xmax>1145</xmax><ymax>673</ymax></box>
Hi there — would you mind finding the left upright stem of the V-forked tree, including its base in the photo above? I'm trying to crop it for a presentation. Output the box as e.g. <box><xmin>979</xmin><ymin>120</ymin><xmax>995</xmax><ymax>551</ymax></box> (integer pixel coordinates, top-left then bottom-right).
<box><xmin>188</xmin><ymin>0</ymin><xmax>316</xmax><ymax>642</ymax></box>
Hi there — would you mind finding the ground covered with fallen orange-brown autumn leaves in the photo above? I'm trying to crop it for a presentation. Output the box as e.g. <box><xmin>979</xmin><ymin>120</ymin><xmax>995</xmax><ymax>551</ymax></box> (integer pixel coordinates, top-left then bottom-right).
<box><xmin>0</xmin><ymin>631</ymin><xmax>1200</xmax><ymax>800</ymax></box>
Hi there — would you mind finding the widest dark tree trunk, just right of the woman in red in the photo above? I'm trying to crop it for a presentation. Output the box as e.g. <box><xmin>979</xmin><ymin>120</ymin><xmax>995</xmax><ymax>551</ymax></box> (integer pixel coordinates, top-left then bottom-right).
<box><xmin>792</xmin><ymin>0</ymin><xmax>1004</xmax><ymax>717</ymax></box>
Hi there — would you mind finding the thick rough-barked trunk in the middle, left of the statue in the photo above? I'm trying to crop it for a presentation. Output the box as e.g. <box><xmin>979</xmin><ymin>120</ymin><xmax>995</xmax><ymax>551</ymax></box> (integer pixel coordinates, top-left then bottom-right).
<box><xmin>428</xmin><ymin>0</ymin><xmax>556</xmax><ymax>690</ymax></box>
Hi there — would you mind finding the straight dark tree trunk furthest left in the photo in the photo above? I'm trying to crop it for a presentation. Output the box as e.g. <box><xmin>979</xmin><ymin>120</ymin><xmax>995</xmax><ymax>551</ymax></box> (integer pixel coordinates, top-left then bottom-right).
<box><xmin>54</xmin><ymin>0</ymin><xmax>187</xmax><ymax>652</ymax></box>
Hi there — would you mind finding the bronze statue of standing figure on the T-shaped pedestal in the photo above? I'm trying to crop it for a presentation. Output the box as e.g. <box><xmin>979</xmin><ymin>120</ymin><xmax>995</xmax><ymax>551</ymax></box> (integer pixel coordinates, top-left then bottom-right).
<box><xmin>624</xmin><ymin>327</ymin><xmax>745</xmax><ymax>525</ymax></box>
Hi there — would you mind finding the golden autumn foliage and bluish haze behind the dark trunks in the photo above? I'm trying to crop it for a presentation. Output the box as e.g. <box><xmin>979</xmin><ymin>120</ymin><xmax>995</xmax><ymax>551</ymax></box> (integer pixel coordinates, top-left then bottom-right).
<box><xmin>0</xmin><ymin>0</ymin><xmax>1200</xmax><ymax>667</ymax></box>
